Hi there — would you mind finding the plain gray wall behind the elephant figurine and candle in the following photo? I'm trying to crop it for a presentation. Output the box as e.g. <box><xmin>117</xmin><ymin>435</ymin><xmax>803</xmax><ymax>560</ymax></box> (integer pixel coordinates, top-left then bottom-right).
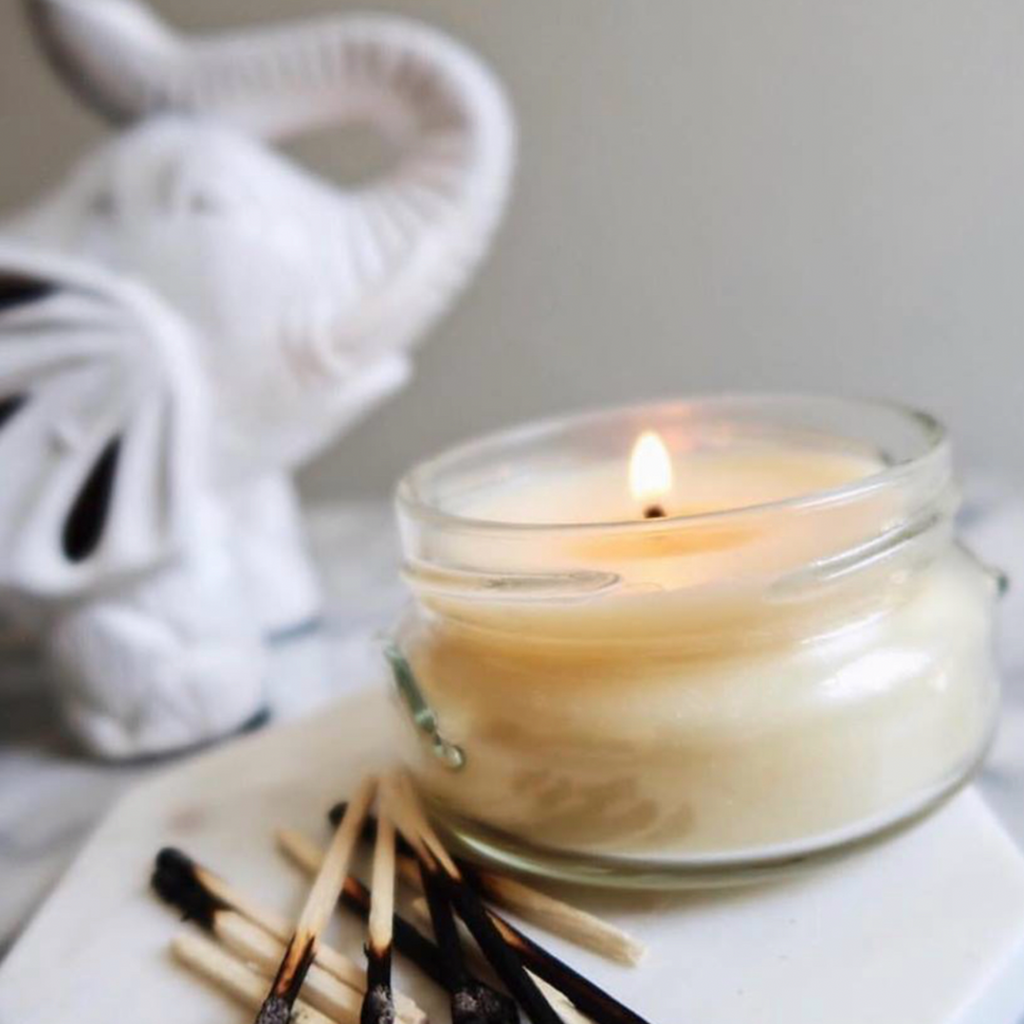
<box><xmin>0</xmin><ymin>0</ymin><xmax>1024</xmax><ymax>495</ymax></box>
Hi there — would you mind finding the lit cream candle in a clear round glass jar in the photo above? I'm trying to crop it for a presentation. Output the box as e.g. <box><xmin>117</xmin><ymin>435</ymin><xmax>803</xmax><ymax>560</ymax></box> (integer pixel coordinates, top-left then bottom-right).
<box><xmin>388</xmin><ymin>396</ymin><xmax>998</xmax><ymax>886</ymax></box>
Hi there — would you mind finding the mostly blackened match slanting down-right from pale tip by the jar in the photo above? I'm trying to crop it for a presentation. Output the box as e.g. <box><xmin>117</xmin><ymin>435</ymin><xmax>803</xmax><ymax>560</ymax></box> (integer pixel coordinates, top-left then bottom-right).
<box><xmin>385</xmin><ymin>776</ymin><xmax>562</xmax><ymax>1024</ymax></box>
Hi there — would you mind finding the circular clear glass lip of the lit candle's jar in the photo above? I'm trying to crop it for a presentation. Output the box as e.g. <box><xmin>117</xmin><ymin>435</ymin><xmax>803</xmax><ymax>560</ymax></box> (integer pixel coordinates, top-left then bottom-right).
<box><xmin>394</xmin><ymin>391</ymin><xmax>949</xmax><ymax>535</ymax></box>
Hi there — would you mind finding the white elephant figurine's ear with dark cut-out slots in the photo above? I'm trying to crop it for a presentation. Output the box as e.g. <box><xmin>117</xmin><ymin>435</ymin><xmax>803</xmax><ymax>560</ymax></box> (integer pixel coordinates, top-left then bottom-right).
<box><xmin>0</xmin><ymin>246</ymin><xmax>206</xmax><ymax>597</ymax></box>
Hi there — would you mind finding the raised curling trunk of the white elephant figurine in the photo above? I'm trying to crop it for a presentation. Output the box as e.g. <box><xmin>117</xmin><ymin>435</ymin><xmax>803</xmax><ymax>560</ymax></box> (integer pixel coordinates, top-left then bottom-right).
<box><xmin>27</xmin><ymin>0</ymin><xmax>515</xmax><ymax>347</ymax></box>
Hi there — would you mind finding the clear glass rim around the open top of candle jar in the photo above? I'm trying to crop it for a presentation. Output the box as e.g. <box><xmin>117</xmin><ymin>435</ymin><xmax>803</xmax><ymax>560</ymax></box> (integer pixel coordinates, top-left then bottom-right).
<box><xmin>395</xmin><ymin>392</ymin><xmax>951</xmax><ymax>536</ymax></box>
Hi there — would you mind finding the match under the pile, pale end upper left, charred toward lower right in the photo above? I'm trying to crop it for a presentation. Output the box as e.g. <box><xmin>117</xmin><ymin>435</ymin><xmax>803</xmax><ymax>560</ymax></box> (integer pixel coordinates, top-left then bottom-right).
<box><xmin>276</xmin><ymin>828</ymin><xmax>518</xmax><ymax>1024</ymax></box>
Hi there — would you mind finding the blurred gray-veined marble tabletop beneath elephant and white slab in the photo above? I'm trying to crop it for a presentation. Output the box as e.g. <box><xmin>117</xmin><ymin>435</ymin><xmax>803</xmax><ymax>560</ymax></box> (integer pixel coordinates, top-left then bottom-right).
<box><xmin>6</xmin><ymin>477</ymin><xmax>1024</xmax><ymax>953</ymax></box>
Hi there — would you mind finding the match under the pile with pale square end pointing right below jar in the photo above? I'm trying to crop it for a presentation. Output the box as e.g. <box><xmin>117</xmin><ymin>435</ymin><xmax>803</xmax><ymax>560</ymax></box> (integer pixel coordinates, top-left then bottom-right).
<box><xmin>328</xmin><ymin>803</ymin><xmax>647</xmax><ymax>967</ymax></box>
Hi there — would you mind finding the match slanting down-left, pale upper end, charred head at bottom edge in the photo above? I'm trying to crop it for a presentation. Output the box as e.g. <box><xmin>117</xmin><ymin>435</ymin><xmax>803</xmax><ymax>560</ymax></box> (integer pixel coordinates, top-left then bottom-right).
<box><xmin>256</xmin><ymin>776</ymin><xmax>377</xmax><ymax>1024</ymax></box>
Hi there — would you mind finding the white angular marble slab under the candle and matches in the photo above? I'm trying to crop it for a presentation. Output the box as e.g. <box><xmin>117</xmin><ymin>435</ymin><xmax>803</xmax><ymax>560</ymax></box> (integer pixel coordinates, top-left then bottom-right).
<box><xmin>0</xmin><ymin>691</ymin><xmax>1024</xmax><ymax>1024</ymax></box>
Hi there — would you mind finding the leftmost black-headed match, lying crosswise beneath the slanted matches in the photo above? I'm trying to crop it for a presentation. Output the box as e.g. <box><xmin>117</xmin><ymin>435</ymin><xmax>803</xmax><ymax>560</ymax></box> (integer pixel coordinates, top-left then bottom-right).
<box><xmin>153</xmin><ymin>848</ymin><xmax>426</xmax><ymax>1024</ymax></box>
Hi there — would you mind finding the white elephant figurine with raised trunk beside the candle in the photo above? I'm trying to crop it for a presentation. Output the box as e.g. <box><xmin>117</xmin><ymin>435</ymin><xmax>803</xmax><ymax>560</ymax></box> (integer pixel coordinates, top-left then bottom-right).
<box><xmin>0</xmin><ymin>0</ymin><xmax>515</xmax><ymax>758</ymax></box>
